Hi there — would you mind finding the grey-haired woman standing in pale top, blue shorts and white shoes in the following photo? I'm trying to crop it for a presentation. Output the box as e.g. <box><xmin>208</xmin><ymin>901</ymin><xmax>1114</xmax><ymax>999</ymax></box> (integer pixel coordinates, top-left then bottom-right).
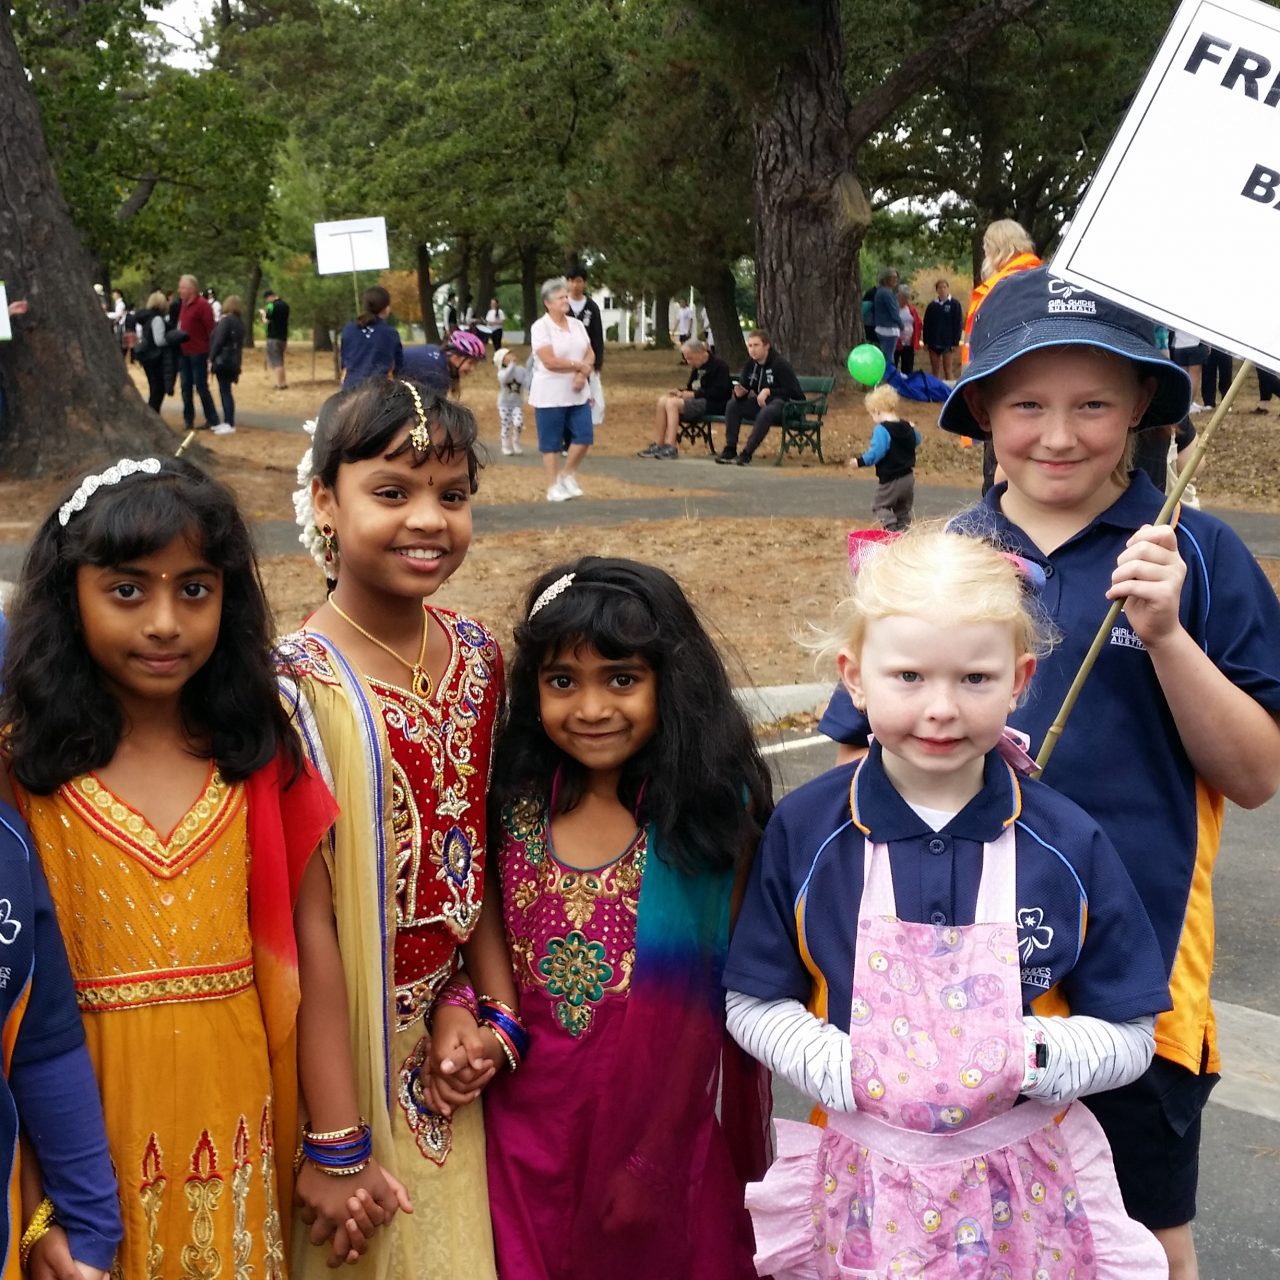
<box><xmin>529</xmin><ymin>275</ymin><xmax>595</xmax><ymax>502</ymax></box>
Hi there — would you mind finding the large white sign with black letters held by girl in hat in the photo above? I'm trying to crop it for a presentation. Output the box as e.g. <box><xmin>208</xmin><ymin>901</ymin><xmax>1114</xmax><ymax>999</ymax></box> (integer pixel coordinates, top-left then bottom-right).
<box><xmin>1050</xmin><ymin>0</ymin><xmax>1280</xmax><ymax>369</ymax></box>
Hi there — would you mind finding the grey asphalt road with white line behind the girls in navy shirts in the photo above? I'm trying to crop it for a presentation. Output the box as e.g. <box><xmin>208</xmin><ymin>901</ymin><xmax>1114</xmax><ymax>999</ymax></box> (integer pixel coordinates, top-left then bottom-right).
<box><xmin>767</xmin><ymin>736</ymin><xmax>1280</xmax><ymax>1280</ymax></box>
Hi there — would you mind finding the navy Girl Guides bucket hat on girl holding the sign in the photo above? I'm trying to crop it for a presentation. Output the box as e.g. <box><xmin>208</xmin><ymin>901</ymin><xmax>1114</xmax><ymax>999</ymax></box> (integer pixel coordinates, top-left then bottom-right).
<box><xmin>938</xmin><ymin>266</ymin><xmax>1192</xmax><ymax>435</ymax></box>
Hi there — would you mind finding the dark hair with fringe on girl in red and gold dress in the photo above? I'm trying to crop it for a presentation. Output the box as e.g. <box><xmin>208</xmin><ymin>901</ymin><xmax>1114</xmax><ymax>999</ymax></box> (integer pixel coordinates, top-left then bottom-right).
<box><xmin>311</xmin><ymin>378</ymin><xmax>484</xmax><ymax>493</ymax></box>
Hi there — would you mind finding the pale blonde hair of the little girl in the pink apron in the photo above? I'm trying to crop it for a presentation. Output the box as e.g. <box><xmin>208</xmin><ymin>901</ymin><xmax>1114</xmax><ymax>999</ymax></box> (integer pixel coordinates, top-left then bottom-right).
<box><xmin>814</xmin><ymin>522</ymin><xmax>1055</xmax><ymax>659</ymax></box>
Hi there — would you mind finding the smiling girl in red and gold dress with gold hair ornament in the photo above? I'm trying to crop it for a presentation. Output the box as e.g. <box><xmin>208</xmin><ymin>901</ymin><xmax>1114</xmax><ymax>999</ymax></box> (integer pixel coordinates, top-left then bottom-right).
<box><xmin>278</xmin><ymin>380</ymin><xmax>515</xmax><ymax>1280</ymax></box>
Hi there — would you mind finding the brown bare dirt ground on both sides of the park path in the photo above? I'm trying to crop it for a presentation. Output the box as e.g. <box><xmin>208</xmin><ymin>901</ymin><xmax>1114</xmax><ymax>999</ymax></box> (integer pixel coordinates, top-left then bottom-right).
<box><xmin>0</xmin><ymin>348</ymin><xmax>1280</xmax><ymax>685</ymax></box>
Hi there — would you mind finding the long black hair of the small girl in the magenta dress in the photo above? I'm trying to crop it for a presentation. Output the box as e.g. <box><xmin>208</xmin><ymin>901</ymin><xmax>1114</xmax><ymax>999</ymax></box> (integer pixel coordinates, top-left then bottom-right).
<box><xmin>493</xmin><ymin>556</ymin><xmax>773</xmax><ymax>873</ymax></box>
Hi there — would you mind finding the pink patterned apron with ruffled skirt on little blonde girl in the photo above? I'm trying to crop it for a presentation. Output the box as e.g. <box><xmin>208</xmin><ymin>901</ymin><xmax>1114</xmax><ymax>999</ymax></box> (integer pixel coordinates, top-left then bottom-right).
<box><xmin>748</xmin><ymin>827</ymin><xmax>1167</xmax><ymax>1280</ymax></box>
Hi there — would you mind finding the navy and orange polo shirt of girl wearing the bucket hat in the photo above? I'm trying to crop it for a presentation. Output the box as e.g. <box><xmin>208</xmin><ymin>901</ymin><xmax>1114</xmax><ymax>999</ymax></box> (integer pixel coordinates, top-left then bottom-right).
<box><xmin>819</xmin><ymin>472</ymin><xmax>1280</xmax><ymax>1070</ymax></box>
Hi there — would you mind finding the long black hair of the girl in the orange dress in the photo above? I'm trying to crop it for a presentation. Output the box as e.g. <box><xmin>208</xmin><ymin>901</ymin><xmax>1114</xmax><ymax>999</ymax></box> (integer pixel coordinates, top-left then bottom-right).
<box><xmin>0</xmin><ymin>458</ymin><xmax>302</xmax><ymax>795</ymax></box>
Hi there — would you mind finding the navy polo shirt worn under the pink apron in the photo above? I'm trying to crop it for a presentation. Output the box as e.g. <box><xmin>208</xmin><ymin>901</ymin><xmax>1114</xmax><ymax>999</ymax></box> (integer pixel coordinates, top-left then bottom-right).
<box><xmin>724</xmin><ymin>745</ymin><xmax>1169</xmax><ymax>1027</ymax></box>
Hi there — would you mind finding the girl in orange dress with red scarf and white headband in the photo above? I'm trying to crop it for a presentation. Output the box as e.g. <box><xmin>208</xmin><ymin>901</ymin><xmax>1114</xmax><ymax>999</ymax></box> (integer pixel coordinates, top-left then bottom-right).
<box><xmin>3</xmin><ymin>458</ymin><xmax>398</xmax><ymax>1280</ymax></box>
